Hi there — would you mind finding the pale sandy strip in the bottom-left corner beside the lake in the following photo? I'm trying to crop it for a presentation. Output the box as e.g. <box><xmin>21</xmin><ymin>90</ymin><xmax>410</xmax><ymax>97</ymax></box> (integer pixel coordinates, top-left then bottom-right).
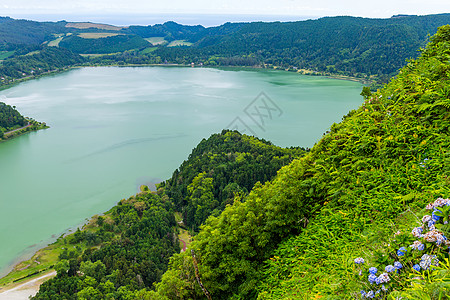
<box><xmin>0</xmin><ymin>271</ymin><xmax>56</xmax><ymax>300</ymax></box>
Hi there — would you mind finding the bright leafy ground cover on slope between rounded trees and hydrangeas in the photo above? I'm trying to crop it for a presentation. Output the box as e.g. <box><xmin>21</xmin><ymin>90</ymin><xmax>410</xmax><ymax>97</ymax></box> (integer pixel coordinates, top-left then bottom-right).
<box><xmin>259</xmin><ymin>26</ymin><xmax>450</xmax><ymax>299</ymax></box>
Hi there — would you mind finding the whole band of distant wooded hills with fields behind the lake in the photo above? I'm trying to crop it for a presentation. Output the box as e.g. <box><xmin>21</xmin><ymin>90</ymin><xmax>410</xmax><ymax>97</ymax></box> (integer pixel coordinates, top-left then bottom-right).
<box><xmin>0</xmin><ymin>14</ymin><xmax>450</xmax><ymax>84</ymax></box>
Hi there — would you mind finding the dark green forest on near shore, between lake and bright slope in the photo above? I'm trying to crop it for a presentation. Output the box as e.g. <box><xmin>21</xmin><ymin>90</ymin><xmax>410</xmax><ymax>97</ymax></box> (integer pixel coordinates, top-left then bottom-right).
<box><xmin>35</xmin><ymin>130</ymin><xmax>306</xmax><ymax>299</ymax></box>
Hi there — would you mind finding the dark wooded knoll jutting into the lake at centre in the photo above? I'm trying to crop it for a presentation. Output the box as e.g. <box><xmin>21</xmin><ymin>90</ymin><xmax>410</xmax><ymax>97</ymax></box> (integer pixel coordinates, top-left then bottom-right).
<box><xmin>159</xmin><ymin>130</ymin><xmax>305</xmax><ymax>231</ymax></box>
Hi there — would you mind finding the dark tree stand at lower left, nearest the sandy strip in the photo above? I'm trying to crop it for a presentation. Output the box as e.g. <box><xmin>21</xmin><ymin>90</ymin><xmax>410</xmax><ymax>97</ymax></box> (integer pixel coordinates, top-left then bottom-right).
<box><xmin>34</xmin><ymin>192</ymin><xmax>180</xmax><ymax>299</ymax></box>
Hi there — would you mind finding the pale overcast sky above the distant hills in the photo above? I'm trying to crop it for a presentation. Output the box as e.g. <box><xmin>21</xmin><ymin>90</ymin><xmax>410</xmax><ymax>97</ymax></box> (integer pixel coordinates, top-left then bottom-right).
<box><xmin>0</xmin><ymin>0</ymin><xmax>450</xmax><ymax>24</ymax></box>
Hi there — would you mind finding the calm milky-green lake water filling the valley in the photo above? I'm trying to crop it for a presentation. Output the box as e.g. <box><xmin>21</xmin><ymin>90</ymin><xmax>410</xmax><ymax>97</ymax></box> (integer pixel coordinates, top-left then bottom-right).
<box><xmin>0</xmin><ymin>67</ymin><xmax>362</xmax><ymax>276</ymax></box>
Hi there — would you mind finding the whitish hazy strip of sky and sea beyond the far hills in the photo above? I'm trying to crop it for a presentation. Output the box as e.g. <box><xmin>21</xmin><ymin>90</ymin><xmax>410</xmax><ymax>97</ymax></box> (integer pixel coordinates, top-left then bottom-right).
<box><xmin>0</xmin><ymin>0</ymin><xmax>450</xmax><ymax>26</ymax></box>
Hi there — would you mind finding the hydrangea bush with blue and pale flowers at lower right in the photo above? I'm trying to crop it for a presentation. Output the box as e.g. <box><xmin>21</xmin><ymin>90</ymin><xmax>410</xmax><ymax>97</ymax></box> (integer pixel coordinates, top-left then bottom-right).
<box><xmin>354</xmin><ymin>198</ymin><xmax>450</xmax><ymax>299</ymax></box>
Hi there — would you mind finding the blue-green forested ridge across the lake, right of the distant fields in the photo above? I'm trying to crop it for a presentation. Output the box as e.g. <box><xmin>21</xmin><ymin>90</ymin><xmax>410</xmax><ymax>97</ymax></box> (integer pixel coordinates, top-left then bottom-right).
<box><xmin>156</xmin><ymin>14</ymin><xmax>450</xmax><ymax>80</ymax></box>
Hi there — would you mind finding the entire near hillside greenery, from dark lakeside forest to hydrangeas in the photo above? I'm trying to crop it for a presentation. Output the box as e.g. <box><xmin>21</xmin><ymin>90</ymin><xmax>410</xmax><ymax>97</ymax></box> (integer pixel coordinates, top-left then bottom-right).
<box><xmin>35</xmin><ymin>25</ymin><xmax>450</xmax><ymax>299</ymax></box>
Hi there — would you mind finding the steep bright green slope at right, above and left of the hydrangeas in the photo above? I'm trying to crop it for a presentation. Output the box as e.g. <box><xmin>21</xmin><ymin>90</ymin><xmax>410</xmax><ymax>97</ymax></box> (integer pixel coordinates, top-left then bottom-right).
<box><xmin>157</xmin><ymin>26</ymin><xmax>450</xmax><ymax>299</ymax></box>
